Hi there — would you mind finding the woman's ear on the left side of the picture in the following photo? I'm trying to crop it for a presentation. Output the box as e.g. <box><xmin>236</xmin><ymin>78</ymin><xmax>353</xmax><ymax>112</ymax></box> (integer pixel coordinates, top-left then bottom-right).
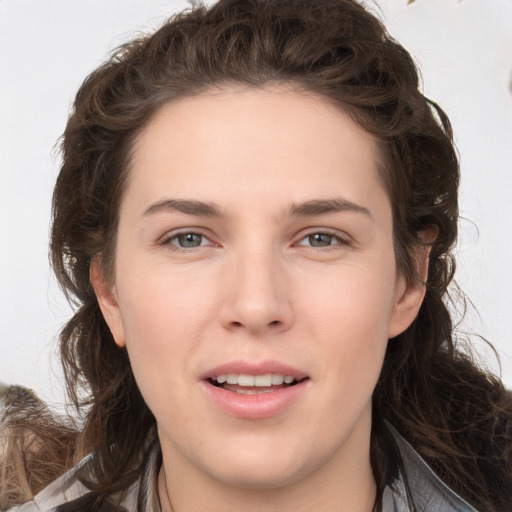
<box><xmin>89</xmin><ymin>256</ymin><xmax>126</xmax><ymax>348</ymax></box>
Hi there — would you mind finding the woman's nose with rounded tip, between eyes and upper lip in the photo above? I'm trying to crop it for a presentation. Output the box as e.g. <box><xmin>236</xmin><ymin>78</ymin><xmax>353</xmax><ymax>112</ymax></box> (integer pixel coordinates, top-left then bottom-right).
<box><xmin>220</xmin><ymin>247</ymin><xmax>293</xmax><ymax>336</ymax></box>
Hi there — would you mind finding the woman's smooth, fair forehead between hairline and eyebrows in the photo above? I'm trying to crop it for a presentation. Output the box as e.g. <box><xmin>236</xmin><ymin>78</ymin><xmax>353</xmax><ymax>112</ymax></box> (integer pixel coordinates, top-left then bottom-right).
<box><xmin>128</xmin><ymin>86</ymin><xmax>383</xmax><ymax>218</ymax></box>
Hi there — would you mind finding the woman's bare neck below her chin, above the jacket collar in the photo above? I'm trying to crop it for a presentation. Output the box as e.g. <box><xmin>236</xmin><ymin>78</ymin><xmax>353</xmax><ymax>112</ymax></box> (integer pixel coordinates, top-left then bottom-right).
<box><xmin>158</xmin><ymin>412</ymin><xmax>376</xmax><ymax>512</ymax></box>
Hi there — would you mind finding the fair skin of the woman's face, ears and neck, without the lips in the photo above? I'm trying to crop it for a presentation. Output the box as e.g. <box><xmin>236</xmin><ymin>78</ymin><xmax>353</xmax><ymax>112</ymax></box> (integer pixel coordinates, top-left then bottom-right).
<box><xmin>91</xmin><ymin>86</ymin><xmax>428</xmax><ymax>512</ymax></box>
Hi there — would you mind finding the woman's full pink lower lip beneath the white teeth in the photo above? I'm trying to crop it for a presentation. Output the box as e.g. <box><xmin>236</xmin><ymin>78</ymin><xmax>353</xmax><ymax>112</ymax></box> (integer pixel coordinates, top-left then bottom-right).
<box><xmin>202</xmin><ymin>379</ymin><xmax>309</xmax><ymax>420</ymax></box>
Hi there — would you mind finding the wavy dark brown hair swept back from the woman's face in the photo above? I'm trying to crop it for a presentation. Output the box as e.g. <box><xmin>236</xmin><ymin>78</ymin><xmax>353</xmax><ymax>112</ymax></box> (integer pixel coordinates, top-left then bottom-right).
<box><xmin>1</xmin><ymin>0</ymin><xmax>512</xmax><ymax>511</ymax></box>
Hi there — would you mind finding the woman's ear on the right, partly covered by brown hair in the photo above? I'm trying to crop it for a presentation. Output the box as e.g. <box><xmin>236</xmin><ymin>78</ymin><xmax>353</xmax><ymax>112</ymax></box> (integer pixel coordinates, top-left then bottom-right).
<box><xmin>388</xmin><ymin>227</ymin><xmax>438</xmax><ymax>338</ymax></box>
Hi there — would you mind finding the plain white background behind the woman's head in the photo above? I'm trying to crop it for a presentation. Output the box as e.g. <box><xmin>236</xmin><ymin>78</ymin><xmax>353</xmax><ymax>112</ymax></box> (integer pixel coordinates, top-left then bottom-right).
<box><xmin>0</xmin><ymin>0</ymin><xmax>512</xmax><ymax>403</ymax></box>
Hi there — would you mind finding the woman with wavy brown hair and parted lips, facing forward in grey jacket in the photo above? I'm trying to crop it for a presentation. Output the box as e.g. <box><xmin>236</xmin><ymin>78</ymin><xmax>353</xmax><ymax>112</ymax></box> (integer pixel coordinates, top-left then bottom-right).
<box><xmin>3</xmin><ymin>0</ymin><xmax>512</xmax><ymax>512</ymax></box>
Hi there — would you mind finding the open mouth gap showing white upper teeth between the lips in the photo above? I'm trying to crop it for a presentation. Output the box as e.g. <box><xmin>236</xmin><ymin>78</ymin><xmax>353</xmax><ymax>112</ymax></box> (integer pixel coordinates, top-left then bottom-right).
<box><xmin>207</xmin><ymin>373</ymin><xmax>308</xmax><ymax>395</ymax></box>
